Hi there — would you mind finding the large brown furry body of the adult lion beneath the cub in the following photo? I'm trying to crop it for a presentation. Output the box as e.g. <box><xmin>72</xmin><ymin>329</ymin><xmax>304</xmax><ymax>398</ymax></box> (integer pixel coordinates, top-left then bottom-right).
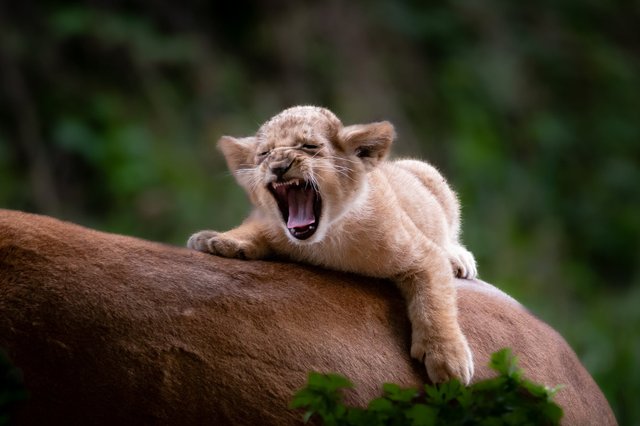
<box><xmin>0</xmin><ymin>210</ymin><xmax>615</xmax><ymax>425</ymax></box>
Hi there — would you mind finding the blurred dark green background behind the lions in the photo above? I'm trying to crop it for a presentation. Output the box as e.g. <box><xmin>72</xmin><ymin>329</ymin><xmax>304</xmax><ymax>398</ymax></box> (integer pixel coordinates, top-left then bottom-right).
<box><xmin>0</xmin><ymin>0</ymin><xmax>640</xmax><ymax>425</ymax></box>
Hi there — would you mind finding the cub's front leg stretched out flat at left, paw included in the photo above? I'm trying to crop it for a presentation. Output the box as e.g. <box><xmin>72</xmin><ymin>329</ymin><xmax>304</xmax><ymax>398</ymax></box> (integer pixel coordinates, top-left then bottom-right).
<box><xmin>187</xmin><ymin>220</ymin><xmax>271</xmax><ymax>260</ymax></box>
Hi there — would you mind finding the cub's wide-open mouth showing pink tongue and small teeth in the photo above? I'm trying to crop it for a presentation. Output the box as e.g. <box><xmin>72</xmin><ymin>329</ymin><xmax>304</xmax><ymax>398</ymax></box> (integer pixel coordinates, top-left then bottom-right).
<box><xmin>268</xmin><ymin>179</ymin><xmax>322</xmax><ymax>240</ymax></box>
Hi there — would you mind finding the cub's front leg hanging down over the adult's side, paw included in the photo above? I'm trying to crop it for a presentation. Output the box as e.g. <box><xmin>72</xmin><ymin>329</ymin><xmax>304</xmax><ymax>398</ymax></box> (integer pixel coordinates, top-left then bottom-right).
<box><xmin>395</xmin><ymin>245</ymin><xmax>474</xmax><ymax>384</ymax></box>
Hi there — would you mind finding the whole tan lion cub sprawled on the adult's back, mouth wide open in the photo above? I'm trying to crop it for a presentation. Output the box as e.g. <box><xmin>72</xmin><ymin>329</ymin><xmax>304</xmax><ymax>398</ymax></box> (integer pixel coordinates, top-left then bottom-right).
<box><xmin>187</xmin><ymin>106</ymin><xmax>476</xmax><ymax>383</ymax></box>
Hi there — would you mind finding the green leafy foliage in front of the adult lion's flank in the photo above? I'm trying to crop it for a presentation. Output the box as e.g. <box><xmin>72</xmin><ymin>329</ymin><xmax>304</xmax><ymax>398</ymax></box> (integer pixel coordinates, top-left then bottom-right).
<box><xmin>291</xmin><ymin>349</ymin><xmax>562</xmax><ymax>426</ymax></box>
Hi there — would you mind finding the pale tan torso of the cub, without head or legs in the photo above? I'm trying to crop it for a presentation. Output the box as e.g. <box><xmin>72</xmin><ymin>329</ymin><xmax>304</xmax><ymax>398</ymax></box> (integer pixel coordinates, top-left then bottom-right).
<box><xmin>259</xmin><ymin>160</ymin><xmax>474</xmax><ymax>278</ymax></box>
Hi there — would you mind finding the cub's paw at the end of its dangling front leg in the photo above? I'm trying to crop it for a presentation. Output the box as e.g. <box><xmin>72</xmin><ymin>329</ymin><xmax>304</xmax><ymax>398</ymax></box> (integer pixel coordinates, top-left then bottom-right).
<box><xmin>411</xmin><ymin>333</ymin><xmax>474</xmax><ymax>385</ymax></box>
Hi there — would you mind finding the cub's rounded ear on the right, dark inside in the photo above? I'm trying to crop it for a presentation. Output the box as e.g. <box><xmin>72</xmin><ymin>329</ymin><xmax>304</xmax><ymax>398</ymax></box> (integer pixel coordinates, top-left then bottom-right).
<box><xmin>338</xmin><ymin>121</ymin><xmax>396</xmax><ymax>170</ymax></box>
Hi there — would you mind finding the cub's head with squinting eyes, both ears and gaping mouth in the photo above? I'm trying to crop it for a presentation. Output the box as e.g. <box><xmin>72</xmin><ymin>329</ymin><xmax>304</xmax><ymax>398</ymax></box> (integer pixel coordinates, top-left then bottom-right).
<box><xmin>218</xmin><ymin>106</ymin><xmax>395</xmax><ymax>242</ymax></box>
